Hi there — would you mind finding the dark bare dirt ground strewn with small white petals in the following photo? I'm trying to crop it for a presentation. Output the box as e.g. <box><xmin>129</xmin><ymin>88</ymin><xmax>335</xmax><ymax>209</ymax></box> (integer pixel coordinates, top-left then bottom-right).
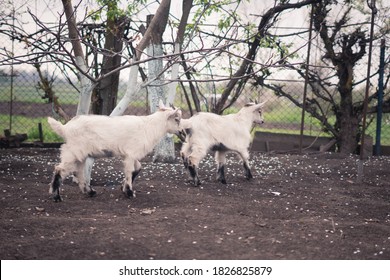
<box><xmin>0</xmin><ymin>148</ymin><xmax>390</xmax><ymax>260</ymax></box>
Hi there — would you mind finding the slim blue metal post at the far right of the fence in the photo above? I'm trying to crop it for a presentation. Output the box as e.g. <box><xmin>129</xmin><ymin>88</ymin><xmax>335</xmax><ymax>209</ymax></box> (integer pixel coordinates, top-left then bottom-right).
<box><xmin>374</xmin><ymin>39</ymin><xmax>385</xmax><ymax>156</ymax></box>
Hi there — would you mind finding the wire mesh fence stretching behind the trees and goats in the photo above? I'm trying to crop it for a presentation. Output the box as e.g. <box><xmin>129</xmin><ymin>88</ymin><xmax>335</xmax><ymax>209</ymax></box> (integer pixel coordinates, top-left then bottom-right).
<box><xmin>0</xmin><ymin>25</ymin><xmax>390</xmax><ymax>154</ymax></box>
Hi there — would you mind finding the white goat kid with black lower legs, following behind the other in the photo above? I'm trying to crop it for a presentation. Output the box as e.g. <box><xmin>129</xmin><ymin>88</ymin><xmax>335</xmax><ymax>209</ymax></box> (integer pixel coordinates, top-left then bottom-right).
<box><xmin>48</xmin><ymin>103</ymin><xmax>181</xmax><ymax>201</ymax></box>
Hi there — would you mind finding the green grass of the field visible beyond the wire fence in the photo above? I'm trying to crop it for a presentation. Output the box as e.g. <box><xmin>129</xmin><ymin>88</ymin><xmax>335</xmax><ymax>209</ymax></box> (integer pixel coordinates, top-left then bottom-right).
<box><xmin>0</xmin><ymin>87</ymin><xmax>390</xmax><ymax>145</ymax></box>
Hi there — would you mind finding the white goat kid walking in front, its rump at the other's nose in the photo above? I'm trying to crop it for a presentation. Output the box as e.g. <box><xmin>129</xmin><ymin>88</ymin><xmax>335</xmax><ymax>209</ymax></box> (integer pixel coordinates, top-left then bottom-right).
<box><xmin>180</xmin><ymin>102</ymin><xmax>265</xmax><ymax>186</ymax></box>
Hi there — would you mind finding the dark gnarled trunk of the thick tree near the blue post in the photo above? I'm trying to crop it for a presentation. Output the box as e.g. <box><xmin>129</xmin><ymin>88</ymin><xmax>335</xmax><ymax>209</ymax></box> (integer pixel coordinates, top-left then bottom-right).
<box><xmin>313</xmin><ymin>2</ymin><xmax>367</xmax><ymax>154</ymax></box>
